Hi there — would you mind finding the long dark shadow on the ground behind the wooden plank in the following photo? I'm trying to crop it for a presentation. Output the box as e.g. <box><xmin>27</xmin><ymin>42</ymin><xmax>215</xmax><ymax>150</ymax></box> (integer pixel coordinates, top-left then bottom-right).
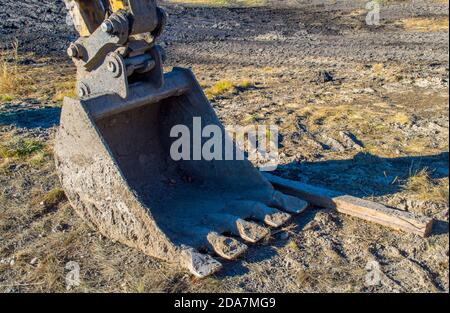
<box><xmin>275</xmin><ymin>152</ymin><xmax>449</xmax><ymax>197</ymax></box>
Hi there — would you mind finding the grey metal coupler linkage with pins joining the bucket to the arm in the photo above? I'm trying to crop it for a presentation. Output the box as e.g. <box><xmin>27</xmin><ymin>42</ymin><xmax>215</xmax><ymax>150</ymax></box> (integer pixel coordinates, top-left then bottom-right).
<box><xmin>67</xmin><ymin>0</ymin><xmax>166</xmax><ymax>98</ymax></box>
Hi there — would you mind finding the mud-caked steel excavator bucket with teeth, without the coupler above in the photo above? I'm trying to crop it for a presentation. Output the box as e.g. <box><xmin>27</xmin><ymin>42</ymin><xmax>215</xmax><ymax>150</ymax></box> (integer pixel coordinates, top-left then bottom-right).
<box><xmin>55</xmin><ymin>68</ymin><xmax>307</xmax><ymax>277</ymax></box>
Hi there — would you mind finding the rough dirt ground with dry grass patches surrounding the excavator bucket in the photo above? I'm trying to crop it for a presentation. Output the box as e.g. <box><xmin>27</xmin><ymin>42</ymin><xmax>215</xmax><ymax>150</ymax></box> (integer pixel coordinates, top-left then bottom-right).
<box><xmin>0</xmin><ymin>0</ymin><xmax>449</xmax><ymax>292</ymax></box>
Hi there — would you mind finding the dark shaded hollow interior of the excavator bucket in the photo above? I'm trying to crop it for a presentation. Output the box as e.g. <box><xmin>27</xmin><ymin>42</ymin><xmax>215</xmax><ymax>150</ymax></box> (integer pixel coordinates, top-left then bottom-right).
<box><xmin>96</xmin><ymin>92</ymin><xmax>265</xmax><ymax>245</ymax></box>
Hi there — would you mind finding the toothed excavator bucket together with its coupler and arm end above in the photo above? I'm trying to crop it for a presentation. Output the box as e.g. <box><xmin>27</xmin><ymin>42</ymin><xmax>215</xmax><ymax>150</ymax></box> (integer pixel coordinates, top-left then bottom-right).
<box><xmin>55</xmin><ymin>0</ymin><xmax>307</xmax><ymax>277</ymax></box>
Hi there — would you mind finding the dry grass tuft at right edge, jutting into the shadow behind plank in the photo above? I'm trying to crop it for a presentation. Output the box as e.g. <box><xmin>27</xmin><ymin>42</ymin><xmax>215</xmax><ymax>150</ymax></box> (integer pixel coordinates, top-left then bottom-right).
<box><xmin>403</xmin><ymin>168</ymin><xmax>449</xmax><ymax>205</ymax></box>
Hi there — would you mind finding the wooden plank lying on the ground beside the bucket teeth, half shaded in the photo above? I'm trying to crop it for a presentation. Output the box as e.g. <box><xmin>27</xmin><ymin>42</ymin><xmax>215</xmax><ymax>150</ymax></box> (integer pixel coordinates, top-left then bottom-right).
<box><xmin>263</xmin><ymin>173</ymin><xmax>433</xmax><ymax>237</ymax></box>
